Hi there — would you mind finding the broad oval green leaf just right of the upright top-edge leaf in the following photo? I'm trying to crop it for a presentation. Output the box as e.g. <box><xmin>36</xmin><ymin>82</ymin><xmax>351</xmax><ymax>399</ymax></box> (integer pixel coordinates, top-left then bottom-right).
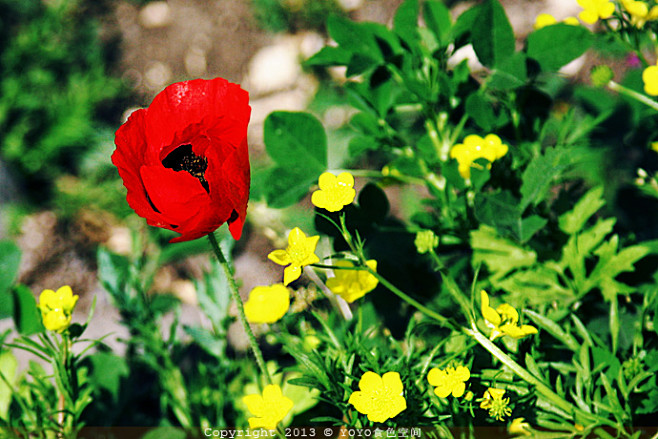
<box><xmin>527</xmin><ymin>23</ymin><xmax>594</xmax><ymax>71</ymax></box>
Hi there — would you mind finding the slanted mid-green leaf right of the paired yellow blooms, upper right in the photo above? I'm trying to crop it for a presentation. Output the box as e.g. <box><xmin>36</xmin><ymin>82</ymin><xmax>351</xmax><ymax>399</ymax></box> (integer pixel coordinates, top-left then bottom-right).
<box><xmin>519</xmin><ymin>148</ymin><xmax>570</xmax><ymax>212</ymax></box>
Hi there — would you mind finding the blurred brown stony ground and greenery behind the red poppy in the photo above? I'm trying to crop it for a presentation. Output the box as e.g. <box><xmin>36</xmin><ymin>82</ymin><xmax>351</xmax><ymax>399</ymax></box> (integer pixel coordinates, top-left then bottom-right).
<box><xmin>0</xmin><ymin>0</ymin><xmax>579</xmax><ymax>354</ymax></box>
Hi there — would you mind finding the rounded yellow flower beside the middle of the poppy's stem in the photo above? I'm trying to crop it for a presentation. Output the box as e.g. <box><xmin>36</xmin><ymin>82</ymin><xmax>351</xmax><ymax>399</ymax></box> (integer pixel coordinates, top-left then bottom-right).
<box><xmin>244</xmin><ymin>284</ymin><xmax>290</xmax><ymax>323</ymax></box>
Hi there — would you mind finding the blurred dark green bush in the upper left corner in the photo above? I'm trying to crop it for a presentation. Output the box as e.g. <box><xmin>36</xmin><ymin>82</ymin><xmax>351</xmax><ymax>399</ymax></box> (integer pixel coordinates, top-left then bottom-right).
<box><xmin>0</xmin><ymin>0</ymin><xmax>124</xmax><ymax>201</ymax></box>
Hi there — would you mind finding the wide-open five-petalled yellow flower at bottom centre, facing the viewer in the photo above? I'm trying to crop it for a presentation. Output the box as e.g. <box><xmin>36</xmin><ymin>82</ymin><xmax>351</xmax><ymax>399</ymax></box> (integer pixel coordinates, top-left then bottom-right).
<box><xmin>348</xmin><ymin>371</ymin><xmax>407</xmax><ymax>422</ymax></box>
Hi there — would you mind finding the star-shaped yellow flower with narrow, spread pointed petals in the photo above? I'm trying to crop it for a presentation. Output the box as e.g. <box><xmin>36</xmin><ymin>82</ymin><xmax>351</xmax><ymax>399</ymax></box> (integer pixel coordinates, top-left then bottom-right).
<box><xmin>267</xmin><ymin>227</ymin><xmax>320</xmax><ymax>285</ymax></box>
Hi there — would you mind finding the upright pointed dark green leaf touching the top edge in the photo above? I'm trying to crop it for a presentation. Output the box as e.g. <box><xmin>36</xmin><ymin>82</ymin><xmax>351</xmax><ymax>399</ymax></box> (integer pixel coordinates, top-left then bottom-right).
<box><xmin>471</xmin><ymin>0</ymin><xmax>515</xmax><ymax>67</ymax></box>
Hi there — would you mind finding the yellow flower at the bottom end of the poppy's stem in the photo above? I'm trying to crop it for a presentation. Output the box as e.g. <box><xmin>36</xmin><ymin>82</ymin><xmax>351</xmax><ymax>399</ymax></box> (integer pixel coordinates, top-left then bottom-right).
<box><xmin>242</xmin><ymin>384</ymin><xmax>293</xmax><ymax>430</ymax></box>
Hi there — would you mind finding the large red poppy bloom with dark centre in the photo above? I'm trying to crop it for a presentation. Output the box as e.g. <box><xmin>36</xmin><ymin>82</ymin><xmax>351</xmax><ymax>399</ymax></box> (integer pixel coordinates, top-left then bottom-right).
<box><xmin>112</xmin><ymin>78</ymin><xmax>251</xmax><ymax>242</ymax></box>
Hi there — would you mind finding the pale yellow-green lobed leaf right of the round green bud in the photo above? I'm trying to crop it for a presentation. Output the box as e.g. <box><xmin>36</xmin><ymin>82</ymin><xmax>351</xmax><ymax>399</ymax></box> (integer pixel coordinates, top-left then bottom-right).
<box><xmin>471</xmin><ymin>225</ymin><xmax>537</xmax><ymax>280</ymax></box>
